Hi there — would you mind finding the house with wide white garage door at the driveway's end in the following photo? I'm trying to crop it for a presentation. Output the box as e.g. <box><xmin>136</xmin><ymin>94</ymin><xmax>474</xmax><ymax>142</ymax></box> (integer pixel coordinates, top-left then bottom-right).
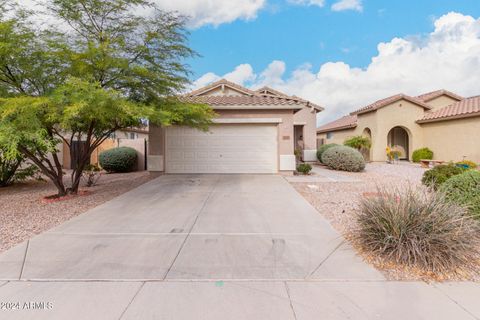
<box><xmin>148</xmin><ymin>80</ymin><xmax>323</xmax><ymax>173</ymax></box>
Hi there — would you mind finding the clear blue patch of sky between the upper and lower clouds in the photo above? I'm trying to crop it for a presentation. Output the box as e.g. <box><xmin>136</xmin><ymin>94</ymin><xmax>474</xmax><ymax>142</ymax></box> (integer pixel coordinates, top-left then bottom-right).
<box><xmin>189</xmin><ymin>0</ymin><xmax>480</xmax><ymax>78</ymax></box>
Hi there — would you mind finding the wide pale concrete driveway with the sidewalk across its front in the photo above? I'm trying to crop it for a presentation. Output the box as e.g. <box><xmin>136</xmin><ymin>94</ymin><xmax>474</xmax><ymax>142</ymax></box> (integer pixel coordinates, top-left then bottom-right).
<box><xmin>0</xmin><ymin>175</ymin><xmax>480</xmax><ymax>320</ymax></box>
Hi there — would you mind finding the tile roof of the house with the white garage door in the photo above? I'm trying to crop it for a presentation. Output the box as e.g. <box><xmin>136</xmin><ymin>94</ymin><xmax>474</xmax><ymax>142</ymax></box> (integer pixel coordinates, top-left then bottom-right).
<box><xmin>182</xmin><ymin>79</ymin><xmax>324</xmax><ymax>111</ymax></box>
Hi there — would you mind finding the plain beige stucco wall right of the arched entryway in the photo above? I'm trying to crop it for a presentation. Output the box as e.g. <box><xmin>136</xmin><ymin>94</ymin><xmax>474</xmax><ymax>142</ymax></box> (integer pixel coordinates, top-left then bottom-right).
<box><xmin>421</xmin><ymin>117</ymin><xmax>480</xmax><ymax>163</ymax></box>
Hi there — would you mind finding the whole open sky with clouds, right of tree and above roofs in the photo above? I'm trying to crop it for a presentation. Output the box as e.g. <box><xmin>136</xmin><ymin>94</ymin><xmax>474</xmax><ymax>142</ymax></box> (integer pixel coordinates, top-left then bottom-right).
<box><xmin>19</xmin><ymin>0</ymin><xmax>480</xmax><ymax>125</ymax></box>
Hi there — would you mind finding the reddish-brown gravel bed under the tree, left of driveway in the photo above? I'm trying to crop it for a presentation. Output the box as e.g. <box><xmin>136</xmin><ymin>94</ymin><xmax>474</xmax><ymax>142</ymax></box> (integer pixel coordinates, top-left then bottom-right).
<box><xmin>0</xmin><ymin>171</ymin><xmax>154</xmax><ymax>252</ymax></box>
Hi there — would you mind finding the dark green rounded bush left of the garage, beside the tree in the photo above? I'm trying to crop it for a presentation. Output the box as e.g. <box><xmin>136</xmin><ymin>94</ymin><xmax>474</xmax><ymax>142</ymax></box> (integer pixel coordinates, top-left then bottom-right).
<box><xmin>99</xmin><ymin>147</ymin><xmax>137</xmax><ymax>172</ymax></box>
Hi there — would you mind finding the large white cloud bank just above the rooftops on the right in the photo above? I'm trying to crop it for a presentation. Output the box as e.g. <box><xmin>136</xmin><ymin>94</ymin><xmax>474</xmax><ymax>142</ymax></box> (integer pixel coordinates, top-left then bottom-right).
<box><xmin>193</xmin><ymin>12</ymin><xmax>480</xmax><ymax>123</ymax></box>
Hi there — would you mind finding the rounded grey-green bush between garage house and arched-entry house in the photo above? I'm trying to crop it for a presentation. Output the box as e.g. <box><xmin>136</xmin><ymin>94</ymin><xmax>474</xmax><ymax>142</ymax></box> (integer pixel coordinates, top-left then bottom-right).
<box><xmin>322</xmin><ymin>146</ymin><xmax>365</xmax><ymax>172</ymax></box>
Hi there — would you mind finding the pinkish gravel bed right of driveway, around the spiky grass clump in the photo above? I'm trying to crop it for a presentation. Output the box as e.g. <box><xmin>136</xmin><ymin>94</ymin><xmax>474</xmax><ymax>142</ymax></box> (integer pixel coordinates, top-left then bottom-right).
<box><xmin>290</xmin><ymin>162</ymin><xmax>479</xmax><ymax>280</ymax></box>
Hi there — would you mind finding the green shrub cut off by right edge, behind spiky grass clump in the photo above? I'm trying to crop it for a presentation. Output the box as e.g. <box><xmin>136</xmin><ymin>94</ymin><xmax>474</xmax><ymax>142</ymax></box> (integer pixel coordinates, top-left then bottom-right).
<box><xmin>439</xmin><ymin>170</ymin><xmax>480</xmax><ymax>219</ymax></box>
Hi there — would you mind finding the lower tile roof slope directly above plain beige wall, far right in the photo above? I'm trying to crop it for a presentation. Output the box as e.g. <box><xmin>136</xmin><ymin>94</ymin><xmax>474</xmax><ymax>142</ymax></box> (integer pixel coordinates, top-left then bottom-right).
<box><xmin>417</xmin><ymin>96</ymin><xmax>480</xmax><ymax>123</ymax></box>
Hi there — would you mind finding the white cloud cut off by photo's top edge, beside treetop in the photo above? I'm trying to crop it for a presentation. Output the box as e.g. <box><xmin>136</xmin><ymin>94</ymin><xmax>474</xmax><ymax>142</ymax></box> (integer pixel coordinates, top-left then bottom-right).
<box><xmin>17</xmin><ymin>0</ymin><xmax>267</xmax><ymax>28</ymax></box>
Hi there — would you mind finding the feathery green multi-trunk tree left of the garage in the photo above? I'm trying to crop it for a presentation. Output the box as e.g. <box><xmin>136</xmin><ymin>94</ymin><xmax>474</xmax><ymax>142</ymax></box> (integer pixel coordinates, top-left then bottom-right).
<box><xmin>0</xmin><ymin>0</ymin><xmax>214</xmax><ymax>195</ymax></box>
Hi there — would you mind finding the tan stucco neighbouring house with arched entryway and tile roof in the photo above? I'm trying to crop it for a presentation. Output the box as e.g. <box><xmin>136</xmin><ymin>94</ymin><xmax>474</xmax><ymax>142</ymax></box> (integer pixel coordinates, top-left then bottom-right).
<box><xmin>317</xmin><ymin>90</ymin><xmax>480</xmax><ymax>162</ymax></box>
